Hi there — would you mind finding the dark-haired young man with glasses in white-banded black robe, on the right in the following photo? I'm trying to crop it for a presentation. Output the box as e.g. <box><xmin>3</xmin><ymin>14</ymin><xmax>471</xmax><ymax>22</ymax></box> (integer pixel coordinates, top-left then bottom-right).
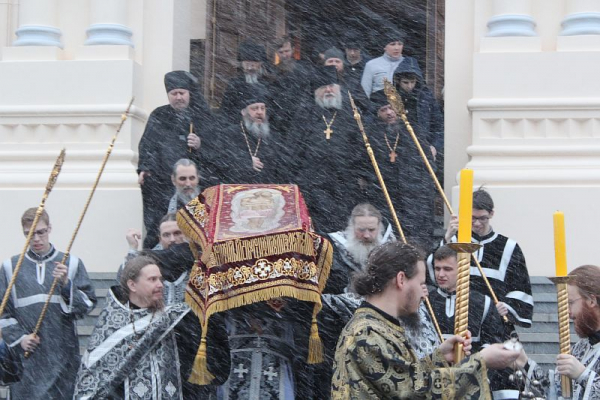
<box><xmin>429</xmin><ymin>188</ymin><xmax>533</xmax><ymax>335</ymax></box>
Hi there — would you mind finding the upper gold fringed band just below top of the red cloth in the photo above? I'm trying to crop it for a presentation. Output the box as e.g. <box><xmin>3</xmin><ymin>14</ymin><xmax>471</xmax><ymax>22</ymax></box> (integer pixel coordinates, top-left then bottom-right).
<box><xmin>209</xmin><ymin>231</ymin><xmax>315</xmax><ymax>268</ymax></box>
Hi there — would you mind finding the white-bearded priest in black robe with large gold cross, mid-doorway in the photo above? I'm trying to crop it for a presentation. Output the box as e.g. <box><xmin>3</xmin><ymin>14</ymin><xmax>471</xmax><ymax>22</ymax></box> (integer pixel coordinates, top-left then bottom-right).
<box><xmin>290</xmin><ymin>66</ymin><xmax>365</xmax><ymax>232</ymax></box>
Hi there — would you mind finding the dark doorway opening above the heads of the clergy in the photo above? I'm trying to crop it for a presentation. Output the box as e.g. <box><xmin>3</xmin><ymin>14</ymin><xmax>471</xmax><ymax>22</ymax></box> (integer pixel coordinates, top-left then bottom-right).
<box><xmin>192</xmin><ymin>0</ymin><xmax>444</xmax><ymax>107</ymax></box>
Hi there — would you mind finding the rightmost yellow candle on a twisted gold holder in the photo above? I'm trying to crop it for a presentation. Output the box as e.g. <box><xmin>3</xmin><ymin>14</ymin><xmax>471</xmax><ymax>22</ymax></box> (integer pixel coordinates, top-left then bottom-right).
<box><xmin>550</xmin><ymin>211</ymin><xmax>571</xmax><ymax>399</ymax></box>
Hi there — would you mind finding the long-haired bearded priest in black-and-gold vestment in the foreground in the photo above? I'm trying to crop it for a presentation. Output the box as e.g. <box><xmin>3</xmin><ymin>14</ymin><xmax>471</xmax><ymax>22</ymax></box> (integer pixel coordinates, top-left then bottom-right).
<box><xmin>332</xmin><ymin>242</ymin><xmax>519</xmax><ymax>400</ymax></box>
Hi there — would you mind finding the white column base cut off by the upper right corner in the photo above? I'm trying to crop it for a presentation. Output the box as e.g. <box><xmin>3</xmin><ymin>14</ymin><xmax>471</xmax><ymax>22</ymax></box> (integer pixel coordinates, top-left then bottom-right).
<box><xmin>560</xmin><ymin>0</ymin><xmax>600</xmax><ymax>36</ymax></box>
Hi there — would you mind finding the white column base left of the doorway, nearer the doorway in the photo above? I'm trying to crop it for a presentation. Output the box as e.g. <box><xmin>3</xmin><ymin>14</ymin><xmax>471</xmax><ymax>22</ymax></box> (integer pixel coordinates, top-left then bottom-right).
<box><xmin>85</xmin><ymin>0</ymin><xmax>133</xmax><ymax>47</ymax></box>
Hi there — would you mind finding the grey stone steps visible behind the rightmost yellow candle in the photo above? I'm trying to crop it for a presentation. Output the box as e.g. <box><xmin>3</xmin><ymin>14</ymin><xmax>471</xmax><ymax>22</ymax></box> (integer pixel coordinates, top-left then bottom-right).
<box><xmin>517</xmin><ymin>276</ymin><xmax>579</xmax><ymax>370</ymax></box>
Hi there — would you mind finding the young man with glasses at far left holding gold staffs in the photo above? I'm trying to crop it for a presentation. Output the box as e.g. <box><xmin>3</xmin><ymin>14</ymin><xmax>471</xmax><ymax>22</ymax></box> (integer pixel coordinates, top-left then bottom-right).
<box><xmin>0</xmin><ymin>208</ymin><xmax>96</xmax><ymax>400</ymax></box>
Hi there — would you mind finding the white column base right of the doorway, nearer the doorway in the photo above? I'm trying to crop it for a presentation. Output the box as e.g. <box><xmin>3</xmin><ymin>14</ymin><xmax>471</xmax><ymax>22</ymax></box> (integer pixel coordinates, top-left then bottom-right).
<box><xmin>487</xmin><ymin>0</ymin><xmax>537</xmax><ymax>37</ymax></box>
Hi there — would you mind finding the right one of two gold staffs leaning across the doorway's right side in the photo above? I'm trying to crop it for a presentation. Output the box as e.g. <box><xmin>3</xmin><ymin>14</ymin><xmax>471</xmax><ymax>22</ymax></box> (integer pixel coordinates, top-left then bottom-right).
<box><xmin>383</xmin><ymin>78</ymin><xmax>509</xmax><ymax>323</ymax></box>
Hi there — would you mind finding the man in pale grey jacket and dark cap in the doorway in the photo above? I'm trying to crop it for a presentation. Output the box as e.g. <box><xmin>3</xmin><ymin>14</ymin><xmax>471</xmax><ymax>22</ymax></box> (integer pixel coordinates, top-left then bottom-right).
<box><xmin>360</xmin><ymin>28</ymin><xmax>419</xmax><ymax>97</ymax></box>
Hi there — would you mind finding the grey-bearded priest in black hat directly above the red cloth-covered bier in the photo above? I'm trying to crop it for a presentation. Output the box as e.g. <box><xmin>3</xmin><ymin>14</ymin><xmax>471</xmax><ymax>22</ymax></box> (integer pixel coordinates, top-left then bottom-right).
<box><xmin>215</xmin><ymin>84</ymin><xmax>291</xmax><ymax>184</ymax></box>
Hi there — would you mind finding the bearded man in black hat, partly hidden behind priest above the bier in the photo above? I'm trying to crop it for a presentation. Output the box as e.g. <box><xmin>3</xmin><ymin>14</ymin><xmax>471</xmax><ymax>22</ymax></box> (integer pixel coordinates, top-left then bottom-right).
<box><xmin>219</xmin><ymin>40</ymin><xmax>267</xmax><ymax>123</ymax></box>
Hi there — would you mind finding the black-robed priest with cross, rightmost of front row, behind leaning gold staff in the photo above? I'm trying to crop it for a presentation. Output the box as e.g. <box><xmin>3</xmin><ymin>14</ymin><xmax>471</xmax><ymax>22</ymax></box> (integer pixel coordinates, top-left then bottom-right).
<box><xmin>362</xmin><ymin>91</ymin><xmax>435</xmax><ymax>250</ymax></box>
